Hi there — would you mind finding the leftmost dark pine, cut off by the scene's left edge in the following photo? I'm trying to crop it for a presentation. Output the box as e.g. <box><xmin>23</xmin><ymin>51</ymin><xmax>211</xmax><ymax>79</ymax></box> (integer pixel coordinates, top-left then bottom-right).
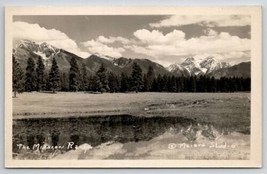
<box><xmin>12</xmin><ymin>55</ymin><xmax>24</xmax><ymax>97</ymax></box>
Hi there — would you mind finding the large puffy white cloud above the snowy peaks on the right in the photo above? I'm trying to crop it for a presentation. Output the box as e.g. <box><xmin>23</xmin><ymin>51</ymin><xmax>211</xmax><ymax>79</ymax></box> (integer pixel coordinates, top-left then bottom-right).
<box><xmin>126</xmin><ymin>29</ymin><xmax>250</xmax><ymax>64</ymax></box>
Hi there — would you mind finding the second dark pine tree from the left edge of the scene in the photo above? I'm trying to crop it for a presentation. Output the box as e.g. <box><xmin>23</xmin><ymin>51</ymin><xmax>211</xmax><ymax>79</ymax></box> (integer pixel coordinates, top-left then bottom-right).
<box><xmin>25</xmin><ymin>57</ymin><xmax>36</xmax><ymax>92</ymax></box>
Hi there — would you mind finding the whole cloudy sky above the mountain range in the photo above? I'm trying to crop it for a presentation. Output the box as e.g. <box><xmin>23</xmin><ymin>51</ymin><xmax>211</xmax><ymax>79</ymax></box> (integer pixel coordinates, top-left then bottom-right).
<box><xmin>13</xmin><ymin>15</ymin><xmax>251</xmax><ymax>66</ymax></box>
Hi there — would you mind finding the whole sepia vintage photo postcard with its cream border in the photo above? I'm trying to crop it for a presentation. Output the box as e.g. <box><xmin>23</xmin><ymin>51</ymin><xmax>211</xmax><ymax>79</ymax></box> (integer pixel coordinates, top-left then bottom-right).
<box><xmin>5</xmin><ymin>6</ymin><xmax>262</xmax><ymax>168</ymax></box>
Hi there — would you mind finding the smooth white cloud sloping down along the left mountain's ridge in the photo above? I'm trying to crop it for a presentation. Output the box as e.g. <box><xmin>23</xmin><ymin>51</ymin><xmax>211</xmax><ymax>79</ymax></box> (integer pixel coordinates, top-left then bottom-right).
<box><xmin>13</xmin><ymin>21</ymin><xmax>89</xmax><ymax>58</ymax></box>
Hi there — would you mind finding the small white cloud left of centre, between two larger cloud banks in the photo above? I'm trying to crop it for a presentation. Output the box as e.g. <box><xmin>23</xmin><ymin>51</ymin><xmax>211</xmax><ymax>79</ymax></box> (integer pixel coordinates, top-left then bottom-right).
<box><xmin>83</xmin><ymin>40</ymin><xmax>125</xmax><ymax>57</ymax></box>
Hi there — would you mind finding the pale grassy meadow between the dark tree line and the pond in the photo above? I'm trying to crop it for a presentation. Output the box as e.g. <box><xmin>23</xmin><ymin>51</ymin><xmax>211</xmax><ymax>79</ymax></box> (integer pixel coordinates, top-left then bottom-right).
<box><xmin>13</xmin><ymin>92</ymin><xmax>250</xmax><ymax>131</ymax></box>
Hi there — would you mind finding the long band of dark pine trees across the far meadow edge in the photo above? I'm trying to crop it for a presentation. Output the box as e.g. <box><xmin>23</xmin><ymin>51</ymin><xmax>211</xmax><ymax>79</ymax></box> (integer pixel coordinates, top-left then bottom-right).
<box><xmin>12</xmin><ymin>55</ymin><xmax>251</xmax><ymax>97</ymax></box>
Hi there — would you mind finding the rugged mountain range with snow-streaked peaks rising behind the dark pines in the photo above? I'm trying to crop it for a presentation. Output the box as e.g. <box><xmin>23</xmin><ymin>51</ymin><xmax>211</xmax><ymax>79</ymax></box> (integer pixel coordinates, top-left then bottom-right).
<box><xmin>13</xmin><ymin>40</ymin><xmax>251</xmax><ymax>78</ymax></box>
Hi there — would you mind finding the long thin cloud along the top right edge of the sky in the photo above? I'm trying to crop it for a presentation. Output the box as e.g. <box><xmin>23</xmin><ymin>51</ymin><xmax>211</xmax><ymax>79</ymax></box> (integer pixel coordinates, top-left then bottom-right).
<box><xmin>149</xmin><ymin>15</ymin><xmax>251</xmax><ymax>28</ymax></box>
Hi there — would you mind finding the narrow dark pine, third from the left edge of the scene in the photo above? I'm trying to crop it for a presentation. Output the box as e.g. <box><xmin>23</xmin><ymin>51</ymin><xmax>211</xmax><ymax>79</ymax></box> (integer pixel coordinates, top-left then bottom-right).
<box><xmin>36</xmin><ymin>56</ymin><xmax>45</xmax><ymax>91</ymax></box>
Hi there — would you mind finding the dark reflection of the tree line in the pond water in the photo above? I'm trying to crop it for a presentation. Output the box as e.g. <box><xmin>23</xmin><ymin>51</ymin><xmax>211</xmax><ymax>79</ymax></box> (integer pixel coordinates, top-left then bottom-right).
<box><xmin>13</xmin><ymin>115</ymin><xmax>199</xmax><ymax>152</ymax></box>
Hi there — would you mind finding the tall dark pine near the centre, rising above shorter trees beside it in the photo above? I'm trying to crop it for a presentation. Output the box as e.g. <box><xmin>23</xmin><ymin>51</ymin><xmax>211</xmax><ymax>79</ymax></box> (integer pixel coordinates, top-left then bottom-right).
<box><xmin>131</xmin><ymin>63</ymin><xmax>144</xmax><ymax>92</ymax></box>
